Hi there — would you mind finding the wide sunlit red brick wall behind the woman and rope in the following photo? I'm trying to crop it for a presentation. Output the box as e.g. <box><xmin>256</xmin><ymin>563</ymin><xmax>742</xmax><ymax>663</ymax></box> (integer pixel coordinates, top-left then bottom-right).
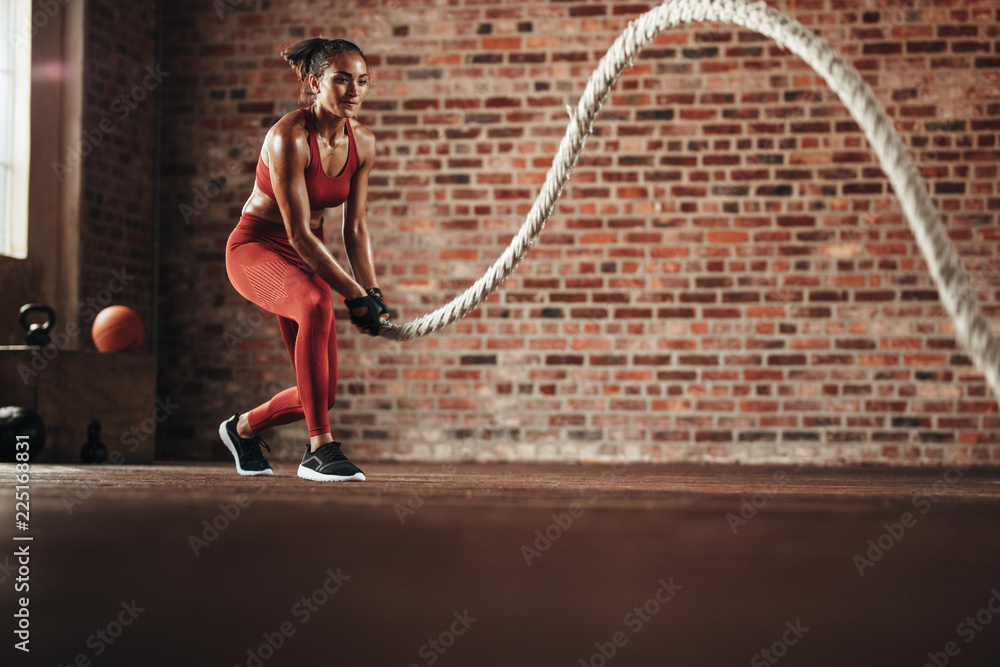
<box><xmin>152</xmin><ymin>0</ymin><xmax>1000</xmax><ymax>465</ymax></box>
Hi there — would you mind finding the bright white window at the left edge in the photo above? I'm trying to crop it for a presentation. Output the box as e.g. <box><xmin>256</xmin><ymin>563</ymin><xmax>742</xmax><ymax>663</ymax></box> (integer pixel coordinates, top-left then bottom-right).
<box><xmin>0</xmin><ymin>0</ymin><xmax>33</xmax><ymax>258</ymax></box>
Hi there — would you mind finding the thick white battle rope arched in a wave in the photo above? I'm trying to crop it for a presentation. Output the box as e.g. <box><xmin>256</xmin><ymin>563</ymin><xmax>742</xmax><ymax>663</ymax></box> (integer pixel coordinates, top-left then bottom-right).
<box><xmin>380</xmin><ymin>0</ymin><xmax>1000</xmax><ymax>397</ymax></box>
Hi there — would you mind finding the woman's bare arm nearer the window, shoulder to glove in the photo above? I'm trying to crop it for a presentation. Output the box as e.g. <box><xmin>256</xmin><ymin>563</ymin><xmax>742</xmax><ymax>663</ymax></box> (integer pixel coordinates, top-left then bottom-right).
<box><xmin>264</xmin><ymin>118</ymin><xmax>365</xmax><ymax>299</ymax></box>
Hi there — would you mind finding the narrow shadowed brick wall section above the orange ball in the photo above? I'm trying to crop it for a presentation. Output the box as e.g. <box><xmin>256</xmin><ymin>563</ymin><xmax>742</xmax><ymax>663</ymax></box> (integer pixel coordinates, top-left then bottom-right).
<box><xmin>77</xmin><ymin>0</ymin><xmax>158</xmax><ymax>349</ymax></box>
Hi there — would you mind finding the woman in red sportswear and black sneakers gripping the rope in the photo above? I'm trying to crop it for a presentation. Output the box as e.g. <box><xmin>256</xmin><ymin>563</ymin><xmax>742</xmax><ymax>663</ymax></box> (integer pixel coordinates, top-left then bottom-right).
<box><xmin>219</xmin><ymin>38</ymin><xmax>389</xmax><ymax>481</ymax></box>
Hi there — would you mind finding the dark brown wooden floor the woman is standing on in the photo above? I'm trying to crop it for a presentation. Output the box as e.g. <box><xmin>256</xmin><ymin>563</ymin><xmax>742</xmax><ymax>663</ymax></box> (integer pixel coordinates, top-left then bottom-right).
<box><xmin>0</xmin><ymin>464</ymin><xmax>1000</xmax><ymax>667</ymax></box>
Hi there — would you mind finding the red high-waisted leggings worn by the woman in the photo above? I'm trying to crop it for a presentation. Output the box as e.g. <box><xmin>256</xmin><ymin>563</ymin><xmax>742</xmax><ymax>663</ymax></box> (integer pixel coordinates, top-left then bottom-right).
<box><xmin>226</xmin><ymin>215</ymin><xmax>337</xmax><ymax>436</ymax></box>
